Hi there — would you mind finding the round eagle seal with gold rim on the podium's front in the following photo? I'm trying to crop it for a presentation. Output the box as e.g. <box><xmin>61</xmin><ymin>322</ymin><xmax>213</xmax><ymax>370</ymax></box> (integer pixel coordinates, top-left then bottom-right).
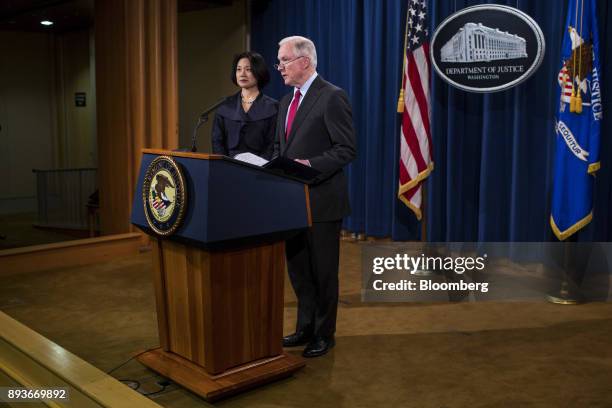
<box><xmin>142</xmin><ymin>156</ymin><xmax>187</xmax><ymax>236</ymax></box>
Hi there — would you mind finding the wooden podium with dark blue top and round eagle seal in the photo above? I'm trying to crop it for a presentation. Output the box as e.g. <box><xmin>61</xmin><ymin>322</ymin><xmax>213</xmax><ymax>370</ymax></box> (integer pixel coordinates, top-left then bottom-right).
<box><xmin>131</xmin><ymin>149</ymin><xmax>311</xmax><ymax>400</ymax></box>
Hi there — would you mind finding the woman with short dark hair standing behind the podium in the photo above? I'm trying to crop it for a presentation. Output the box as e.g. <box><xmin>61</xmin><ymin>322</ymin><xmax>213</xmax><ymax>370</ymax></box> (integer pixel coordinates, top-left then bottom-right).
<box><xmin>212</xmin><ymin>52</ymin><xmax>278</xmax><ymax>160</ymax></box>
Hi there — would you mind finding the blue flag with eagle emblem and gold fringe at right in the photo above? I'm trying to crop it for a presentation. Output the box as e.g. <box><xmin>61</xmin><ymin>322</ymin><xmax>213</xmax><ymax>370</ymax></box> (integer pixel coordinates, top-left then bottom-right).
<box><xmin>550</xmin><ymin>0</ymin><xmax>602</xmax><ymax>240</ymax></box>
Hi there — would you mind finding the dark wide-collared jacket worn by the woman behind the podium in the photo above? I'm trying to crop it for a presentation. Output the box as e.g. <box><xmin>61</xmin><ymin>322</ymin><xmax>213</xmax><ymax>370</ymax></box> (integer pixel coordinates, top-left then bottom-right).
<box><xmin>211</xmin><ymin>92</ymin><xmax>278</xmax><ymax>160</ymax></box>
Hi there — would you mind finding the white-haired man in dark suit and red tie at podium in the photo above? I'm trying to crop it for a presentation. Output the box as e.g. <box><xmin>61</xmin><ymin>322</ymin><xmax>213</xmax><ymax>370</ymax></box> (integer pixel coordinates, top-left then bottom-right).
<box><xmin>274</xmin><ymin>37</ymin><xmax>356</xmax><ymax>357</ymax></box>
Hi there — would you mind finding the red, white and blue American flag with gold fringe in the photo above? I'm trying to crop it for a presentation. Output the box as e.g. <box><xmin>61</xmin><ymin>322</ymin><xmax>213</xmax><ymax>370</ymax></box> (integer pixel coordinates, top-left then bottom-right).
<box><xmin>398</xmin><ymin>0</ymin><xmax>433</xmax><ymax>220</ymax></box>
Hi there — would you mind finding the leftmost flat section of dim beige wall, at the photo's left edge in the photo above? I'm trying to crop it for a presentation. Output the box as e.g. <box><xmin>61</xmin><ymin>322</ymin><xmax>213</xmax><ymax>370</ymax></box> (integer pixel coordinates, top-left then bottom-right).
<box><xmin>0</xmin><ymin>31</ymin><xmax>55</xmax><ymax>212</ymax></box>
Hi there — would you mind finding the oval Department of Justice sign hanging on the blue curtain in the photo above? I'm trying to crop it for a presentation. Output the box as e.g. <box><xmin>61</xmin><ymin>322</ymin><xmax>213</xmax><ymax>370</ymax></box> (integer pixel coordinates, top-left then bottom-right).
<box><xmin>430</xmin><ymin>4</ymin><xmax>546</xmax><ymax>92</ymax></box>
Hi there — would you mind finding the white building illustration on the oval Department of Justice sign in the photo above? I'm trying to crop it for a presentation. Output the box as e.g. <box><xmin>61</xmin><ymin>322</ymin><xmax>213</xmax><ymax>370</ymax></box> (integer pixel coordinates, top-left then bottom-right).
<box><xmin>440</xmin><ymin>23</ymin><xmax>527</xmax><ymax>62</ymax></box>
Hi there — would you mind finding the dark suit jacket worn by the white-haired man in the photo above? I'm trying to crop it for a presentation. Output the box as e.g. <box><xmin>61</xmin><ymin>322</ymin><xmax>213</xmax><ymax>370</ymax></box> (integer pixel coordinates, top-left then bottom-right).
<box><xmin>274</xmin><ymin>75</ymin><xmax>357</xmax><ymax>222</ymax></box>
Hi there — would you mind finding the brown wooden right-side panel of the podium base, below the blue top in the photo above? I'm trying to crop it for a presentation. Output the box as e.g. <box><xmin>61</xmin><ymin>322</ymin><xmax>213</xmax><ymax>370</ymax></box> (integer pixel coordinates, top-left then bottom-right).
<box><xmin>206</xmin><ymin>242</ymin><xmax>285</xmax><ymax>373</ymax></box>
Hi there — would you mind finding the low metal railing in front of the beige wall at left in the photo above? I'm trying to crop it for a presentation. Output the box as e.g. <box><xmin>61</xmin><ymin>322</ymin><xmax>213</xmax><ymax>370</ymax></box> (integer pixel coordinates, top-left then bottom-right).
<box><xmin>32</xmin><ymin>168</ymin><xmax>98</xmax><ymax>229</ymax></box>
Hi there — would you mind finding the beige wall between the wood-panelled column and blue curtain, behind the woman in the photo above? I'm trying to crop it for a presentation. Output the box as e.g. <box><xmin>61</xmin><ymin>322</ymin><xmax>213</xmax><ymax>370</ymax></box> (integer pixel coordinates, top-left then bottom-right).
<box><xmin>178</xmin><ymin>0</ymin><xmax>247</xmax><ymax>152</ymax></box>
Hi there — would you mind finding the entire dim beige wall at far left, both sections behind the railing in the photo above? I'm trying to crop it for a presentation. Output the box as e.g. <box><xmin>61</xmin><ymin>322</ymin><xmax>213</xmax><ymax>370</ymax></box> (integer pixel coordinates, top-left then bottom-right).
<box><xmin>0</xmin><ymin>31</ymin><xmax>96</xmax><ymax>213</ymax></box>
